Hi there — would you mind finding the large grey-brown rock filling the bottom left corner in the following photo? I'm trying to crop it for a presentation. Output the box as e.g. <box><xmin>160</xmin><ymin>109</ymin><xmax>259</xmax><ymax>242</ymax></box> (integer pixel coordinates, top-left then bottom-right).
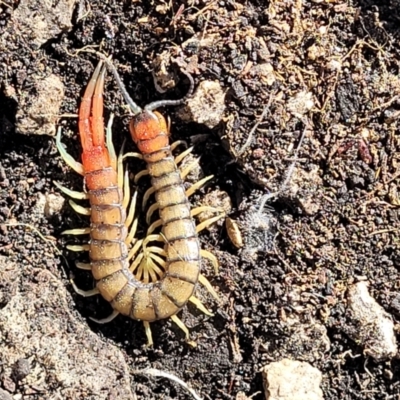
<box><xmin>0</xmin><ymin>257</ymin><xmax>136</xmax><ymax>400</ymax></box>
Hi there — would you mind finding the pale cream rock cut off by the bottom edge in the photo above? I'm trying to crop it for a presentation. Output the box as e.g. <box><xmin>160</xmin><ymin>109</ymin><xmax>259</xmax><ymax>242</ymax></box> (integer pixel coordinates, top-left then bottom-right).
<box><xmin>262</xmin><ymin>358</ymin><xmax>323</xmax><ymax>400</ymax></box>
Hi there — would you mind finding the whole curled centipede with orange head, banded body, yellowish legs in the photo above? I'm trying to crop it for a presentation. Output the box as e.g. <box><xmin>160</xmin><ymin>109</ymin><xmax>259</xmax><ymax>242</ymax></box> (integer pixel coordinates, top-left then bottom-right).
<box><xmin>55</xmin><ymin>54</ymin><xmax>223</xmax><ymax>346</ymax></box>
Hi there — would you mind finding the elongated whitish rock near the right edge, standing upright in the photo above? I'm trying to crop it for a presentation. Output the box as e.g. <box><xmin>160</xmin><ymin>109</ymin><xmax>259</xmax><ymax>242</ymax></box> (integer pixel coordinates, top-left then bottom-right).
<box><xmin>346</xmin><ymin>282</ymin><xmax>397</xmax><ymax>361</ymax></box>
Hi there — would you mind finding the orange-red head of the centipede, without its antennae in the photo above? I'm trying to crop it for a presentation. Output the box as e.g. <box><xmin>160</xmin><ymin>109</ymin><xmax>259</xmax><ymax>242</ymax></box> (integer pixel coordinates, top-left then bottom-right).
<box><xmin>129</xmin><ymin>110</ymin><xmax>169</xmax><ymax>154</ymax></box>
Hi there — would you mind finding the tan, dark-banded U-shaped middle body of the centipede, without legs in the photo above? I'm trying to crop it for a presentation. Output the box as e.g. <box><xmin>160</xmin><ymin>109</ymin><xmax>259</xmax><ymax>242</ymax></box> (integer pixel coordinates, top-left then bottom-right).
<box><xmin>85</xmin><ymin>147</ymin><xmax>200</xmax><ymax>322</ymax></box>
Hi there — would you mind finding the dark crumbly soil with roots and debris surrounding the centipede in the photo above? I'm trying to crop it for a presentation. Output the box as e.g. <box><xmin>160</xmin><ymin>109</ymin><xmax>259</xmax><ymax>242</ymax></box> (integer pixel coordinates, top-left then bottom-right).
<box><xmin>0</xmin><ymin>0</ymin><xmax>400</xmax><ymax>400</ymax></box>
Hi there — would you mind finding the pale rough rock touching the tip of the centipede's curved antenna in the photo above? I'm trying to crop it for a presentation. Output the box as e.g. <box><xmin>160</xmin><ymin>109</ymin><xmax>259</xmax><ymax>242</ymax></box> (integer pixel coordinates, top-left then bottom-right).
<box><xmin>179</xmin><ymin>81</ymin><xmax>225</xmax><ymax>129</ymax></box>
